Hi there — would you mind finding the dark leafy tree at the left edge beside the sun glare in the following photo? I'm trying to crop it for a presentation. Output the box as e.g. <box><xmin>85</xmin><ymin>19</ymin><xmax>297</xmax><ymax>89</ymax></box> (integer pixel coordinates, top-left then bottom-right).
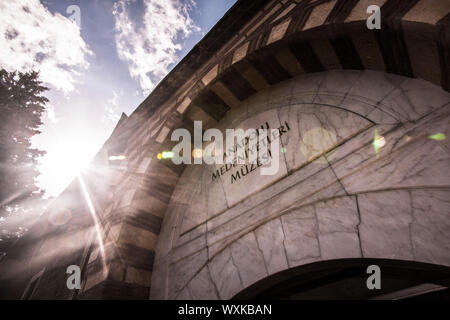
<box><xmin>0</xmin><ymin>69</ymin><xmax>48</xmax><ymax>255</ymax></box>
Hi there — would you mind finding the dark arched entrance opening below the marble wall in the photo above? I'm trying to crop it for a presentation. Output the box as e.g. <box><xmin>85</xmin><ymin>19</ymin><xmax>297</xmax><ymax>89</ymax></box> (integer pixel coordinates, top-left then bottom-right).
<box><xmin>232</xmin><ymin>259</ymin><xmax>450</xmax><ymax>300</ymax></box>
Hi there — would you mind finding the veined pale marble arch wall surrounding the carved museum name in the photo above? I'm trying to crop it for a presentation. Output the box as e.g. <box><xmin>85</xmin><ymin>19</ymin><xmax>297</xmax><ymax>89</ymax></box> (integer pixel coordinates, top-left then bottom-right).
<box><xmin>150</xmin><ymin>71</ymin><xmax>450</xmax><ymax>299</ymax></box>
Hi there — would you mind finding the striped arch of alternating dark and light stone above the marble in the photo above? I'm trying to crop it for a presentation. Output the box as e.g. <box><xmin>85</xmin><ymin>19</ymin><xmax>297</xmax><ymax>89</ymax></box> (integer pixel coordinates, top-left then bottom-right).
<box><xmin>186</xmin><ymin>1</ymin><xmax>449</xmax><ymax>127</ymax></box>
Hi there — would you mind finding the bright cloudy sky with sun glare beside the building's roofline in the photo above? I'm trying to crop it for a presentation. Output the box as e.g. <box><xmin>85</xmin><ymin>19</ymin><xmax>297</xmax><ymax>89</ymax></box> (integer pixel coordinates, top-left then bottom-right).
<box><xmin>0</xmin><ymin>0</ymin><xmax>236</xmax><ymax>197</ymax></box>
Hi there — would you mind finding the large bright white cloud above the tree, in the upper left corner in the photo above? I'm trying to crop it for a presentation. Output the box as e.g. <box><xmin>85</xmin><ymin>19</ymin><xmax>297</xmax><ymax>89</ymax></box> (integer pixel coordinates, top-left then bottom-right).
<box><xmin>0</xmin><ymin>0</ymin><xmax>93</xmax><ymax>92</ymax></box>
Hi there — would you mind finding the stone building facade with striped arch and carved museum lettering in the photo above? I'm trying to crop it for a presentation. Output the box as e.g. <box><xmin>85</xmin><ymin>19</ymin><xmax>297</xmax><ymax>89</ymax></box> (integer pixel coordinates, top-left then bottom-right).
<box><xmin>0</xmin><ymin>0</ymin><xmax>450</xmax><ymax>299</ymax></box>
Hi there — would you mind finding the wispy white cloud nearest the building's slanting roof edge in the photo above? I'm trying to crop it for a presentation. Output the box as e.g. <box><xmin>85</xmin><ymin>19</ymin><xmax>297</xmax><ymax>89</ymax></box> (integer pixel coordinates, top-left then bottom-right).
<box><xmin>113</xmin><ymin>0</ymin><xmax>200</xmax><ymax>94</ymax></box>
